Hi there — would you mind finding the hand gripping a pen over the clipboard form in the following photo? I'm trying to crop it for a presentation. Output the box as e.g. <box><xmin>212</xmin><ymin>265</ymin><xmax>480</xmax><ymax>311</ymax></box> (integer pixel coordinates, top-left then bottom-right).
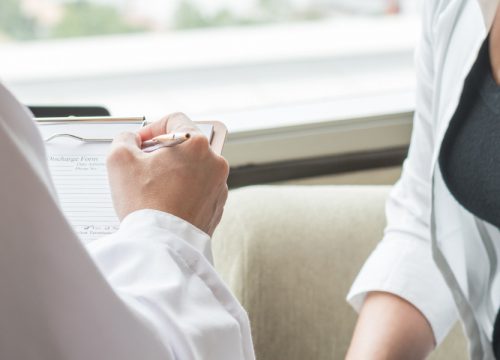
<box><xmin>107</xmin><ymin>113</ymin><xmax>229</xmax><ymax>235</ymax></box>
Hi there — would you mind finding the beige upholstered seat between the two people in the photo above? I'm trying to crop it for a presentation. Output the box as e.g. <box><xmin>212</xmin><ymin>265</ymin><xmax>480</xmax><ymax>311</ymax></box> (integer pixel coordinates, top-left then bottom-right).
<box><xmin>213</xmin><ymin>186</ymin><xmax>467</xmax><ymax>360</ymax></box>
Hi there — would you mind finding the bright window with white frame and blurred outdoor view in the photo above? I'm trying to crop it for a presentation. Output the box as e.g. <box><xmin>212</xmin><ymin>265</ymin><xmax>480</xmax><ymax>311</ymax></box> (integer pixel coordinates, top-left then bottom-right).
<box><xmin>0</xmin><ymin>0</ymin><xmax>418</xmax><ymax>165</ymax></box>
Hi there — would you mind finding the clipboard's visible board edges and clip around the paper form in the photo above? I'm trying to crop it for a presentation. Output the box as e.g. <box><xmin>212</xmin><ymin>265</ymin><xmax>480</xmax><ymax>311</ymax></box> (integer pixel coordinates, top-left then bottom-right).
<box><xmin>34</xmin><ymin>116</ymin><xmax>227</xmax><ymax>155</ymax></box>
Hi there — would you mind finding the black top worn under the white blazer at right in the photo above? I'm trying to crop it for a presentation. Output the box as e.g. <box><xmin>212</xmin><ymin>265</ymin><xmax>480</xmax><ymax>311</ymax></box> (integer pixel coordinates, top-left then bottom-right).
<box><xmin>439</xmin><ymin>38</ymin><xmax>500</xmax><ymax>359</ymax></box>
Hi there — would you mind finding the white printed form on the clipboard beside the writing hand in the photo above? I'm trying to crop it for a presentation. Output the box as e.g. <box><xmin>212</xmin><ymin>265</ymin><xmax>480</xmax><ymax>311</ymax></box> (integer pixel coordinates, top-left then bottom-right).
<box><xmin>39</xmin><ymin>122</ymin><xmax>213</xmax><ymax>243</ymax></box>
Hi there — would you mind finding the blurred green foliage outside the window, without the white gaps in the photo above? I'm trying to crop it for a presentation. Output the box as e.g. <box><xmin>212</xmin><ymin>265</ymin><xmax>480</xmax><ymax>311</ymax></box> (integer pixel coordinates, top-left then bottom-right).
<box><xmin>0</xmin><ymin>0</ymin><xmax>394</xmax><ymax>41</ymax></box>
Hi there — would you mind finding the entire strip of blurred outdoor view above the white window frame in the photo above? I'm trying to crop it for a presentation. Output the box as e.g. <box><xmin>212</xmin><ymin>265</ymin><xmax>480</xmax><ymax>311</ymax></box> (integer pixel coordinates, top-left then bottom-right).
<box><xmin>0</xmin><ymin>0</ymin><xmax>414</xmax><ymax>41</ymax></box>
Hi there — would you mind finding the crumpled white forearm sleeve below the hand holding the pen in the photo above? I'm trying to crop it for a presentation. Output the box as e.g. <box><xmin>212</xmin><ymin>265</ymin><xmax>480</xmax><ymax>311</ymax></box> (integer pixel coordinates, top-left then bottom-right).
<box><xmin>88</xmin><ymin>210</ymin><xmax>254</xmax><ymax>360</ymax></box>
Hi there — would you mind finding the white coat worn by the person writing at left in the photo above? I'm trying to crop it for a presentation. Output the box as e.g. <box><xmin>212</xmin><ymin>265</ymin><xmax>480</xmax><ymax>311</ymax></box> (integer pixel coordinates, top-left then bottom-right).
<box><xmin>0</xmin><ymin>81</ymin><xmax>254</xmax><ymax>360</ymax></box>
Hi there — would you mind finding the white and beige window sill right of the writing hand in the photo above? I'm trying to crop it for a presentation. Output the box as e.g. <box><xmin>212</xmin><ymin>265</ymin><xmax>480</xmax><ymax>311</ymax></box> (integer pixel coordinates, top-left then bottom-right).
<box><xmin>203</xmin><ymin>91</ymin><xmax>414</xmax><ymax>167</ymax></box>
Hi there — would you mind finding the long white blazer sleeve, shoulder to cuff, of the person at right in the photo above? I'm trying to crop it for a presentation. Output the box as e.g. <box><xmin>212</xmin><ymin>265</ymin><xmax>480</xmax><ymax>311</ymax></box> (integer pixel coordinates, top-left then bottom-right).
<box><xmin>347</xmin><ymin>0</ymin><xmax>457</xmax><ymax>344</ymax></box>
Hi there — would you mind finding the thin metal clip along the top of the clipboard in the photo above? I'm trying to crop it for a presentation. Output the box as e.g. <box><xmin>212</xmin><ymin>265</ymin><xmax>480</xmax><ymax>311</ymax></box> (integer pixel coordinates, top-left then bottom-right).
<box><xmin>35</xmin><ymin>116</ymin><xmax>146</xmax><ymax>143</ymax></box>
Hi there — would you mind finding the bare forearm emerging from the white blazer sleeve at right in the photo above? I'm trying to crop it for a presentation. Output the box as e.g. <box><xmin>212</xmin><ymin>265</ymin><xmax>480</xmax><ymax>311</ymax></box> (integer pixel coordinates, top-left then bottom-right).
<box><xmin>346</xmin><ymin>292</ymin><xmax>435</xmax><ymax>360</ymax></box>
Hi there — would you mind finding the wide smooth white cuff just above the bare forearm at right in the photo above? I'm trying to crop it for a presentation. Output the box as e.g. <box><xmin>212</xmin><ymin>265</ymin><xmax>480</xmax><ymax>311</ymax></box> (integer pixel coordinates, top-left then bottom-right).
<box><xmin>347</xmin><ymin>234</ymin><xmax>457</xmax><ymax>345</ymax></box>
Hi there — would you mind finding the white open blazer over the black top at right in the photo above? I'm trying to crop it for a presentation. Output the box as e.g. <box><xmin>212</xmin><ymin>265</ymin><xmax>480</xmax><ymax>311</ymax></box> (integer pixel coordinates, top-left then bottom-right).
<box><xmin>348</xmin><ymin>0</ymin><xmax>500</xmax><ymax>359</ymax></box>
